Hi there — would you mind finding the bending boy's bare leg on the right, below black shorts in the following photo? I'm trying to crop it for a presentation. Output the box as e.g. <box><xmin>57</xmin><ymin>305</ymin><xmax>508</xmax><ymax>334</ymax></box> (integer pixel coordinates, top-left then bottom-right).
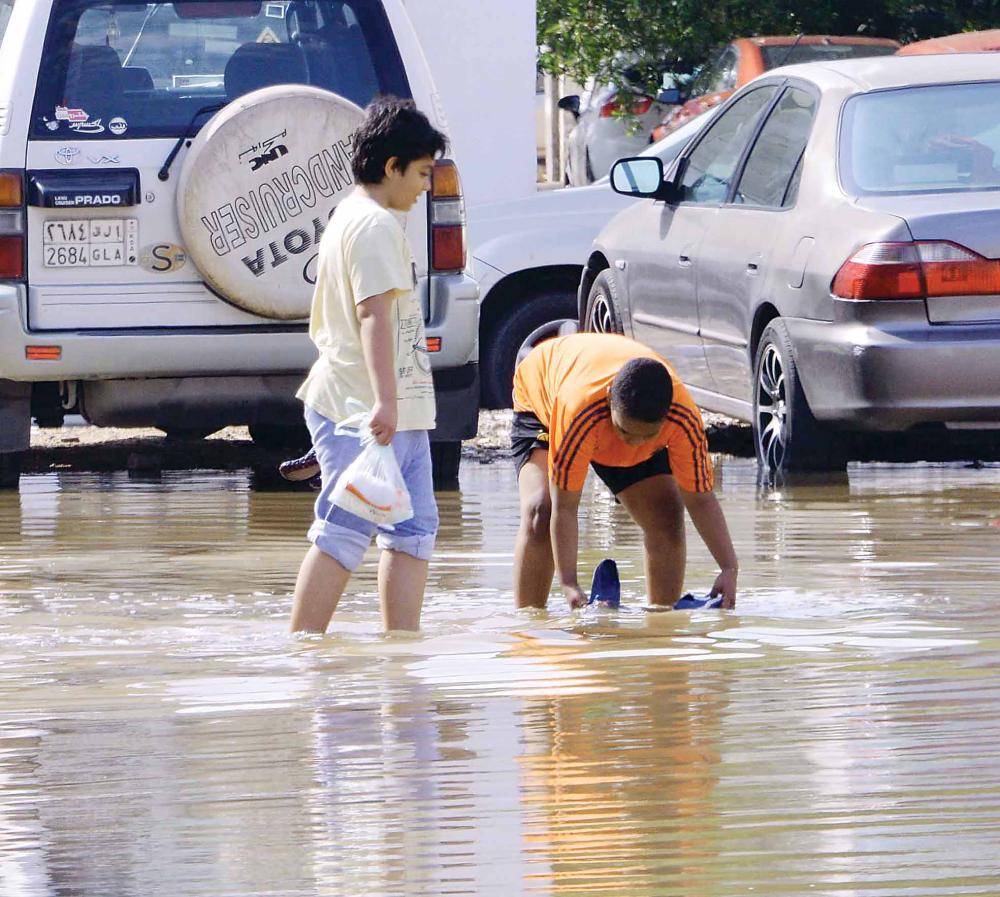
<box><xmin>618</xmin><ymin>474</ymin><xmax>687</xmax><ymax>607</ymax></box>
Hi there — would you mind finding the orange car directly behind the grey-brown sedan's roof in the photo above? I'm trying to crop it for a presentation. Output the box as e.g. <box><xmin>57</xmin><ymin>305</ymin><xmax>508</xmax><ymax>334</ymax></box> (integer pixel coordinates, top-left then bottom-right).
<box><xmin>653</xmin><ymin>34</ymin><xmax>899</xmax><ymax>142</ymax></box>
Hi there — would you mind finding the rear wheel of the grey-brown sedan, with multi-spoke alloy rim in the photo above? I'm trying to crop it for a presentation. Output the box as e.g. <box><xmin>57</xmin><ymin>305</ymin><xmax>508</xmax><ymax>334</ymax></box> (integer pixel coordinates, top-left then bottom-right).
<box><xmin>752</xmin><ymin>318</ymin><xmax>847</xmax><ymax>472</ymax></box>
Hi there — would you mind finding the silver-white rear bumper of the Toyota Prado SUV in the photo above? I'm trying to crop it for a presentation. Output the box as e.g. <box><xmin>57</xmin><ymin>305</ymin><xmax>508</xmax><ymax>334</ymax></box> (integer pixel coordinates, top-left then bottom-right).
<box><xmin>0</xmin><ymin>274</ymin><xmax>479</xmax><ymax>452</ymax></box>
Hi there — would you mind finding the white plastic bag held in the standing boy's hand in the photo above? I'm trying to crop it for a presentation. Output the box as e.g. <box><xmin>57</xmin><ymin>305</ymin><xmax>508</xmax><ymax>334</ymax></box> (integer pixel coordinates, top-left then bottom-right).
<box><xmin>330</xmin><ymin>406</ymin><xmax>413</xmax><ymax>526</ymax></box>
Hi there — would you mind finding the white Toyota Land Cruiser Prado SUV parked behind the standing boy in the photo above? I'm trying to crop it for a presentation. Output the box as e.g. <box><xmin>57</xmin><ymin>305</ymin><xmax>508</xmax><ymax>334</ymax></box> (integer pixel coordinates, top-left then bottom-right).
<box><xmin>0</xmin><ymin>0</ymin><xmax>478</xmax><ymax>485</ymax></box>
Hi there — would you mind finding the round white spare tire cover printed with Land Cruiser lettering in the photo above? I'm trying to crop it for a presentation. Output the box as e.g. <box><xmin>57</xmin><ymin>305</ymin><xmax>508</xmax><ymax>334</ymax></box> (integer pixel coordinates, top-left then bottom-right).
<box><xmin>177</xmin><ymin>84</ymin><xmax>364</xmax><ymax>320</ymax></box>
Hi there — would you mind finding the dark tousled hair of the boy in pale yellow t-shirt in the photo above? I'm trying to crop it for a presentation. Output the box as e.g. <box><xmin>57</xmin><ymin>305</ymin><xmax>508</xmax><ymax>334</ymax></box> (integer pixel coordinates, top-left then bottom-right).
<box><xmin>351</xmin><ymin>96</ymin><xmax>448</xmax><ymax>184</ymax></box>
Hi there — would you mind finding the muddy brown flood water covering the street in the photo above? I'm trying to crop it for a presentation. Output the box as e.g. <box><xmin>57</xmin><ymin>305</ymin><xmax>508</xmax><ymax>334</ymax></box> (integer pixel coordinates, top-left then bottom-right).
<box><xmin>0</xmin><ymin>459</ymin><xmax>1000</xmax><ymax>897</ymax></box>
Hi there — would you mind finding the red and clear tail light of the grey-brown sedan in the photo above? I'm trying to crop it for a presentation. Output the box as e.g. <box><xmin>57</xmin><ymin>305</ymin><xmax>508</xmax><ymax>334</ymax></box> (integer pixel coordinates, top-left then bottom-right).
<box><xmin>831</xmin><ymin>240</ymin><xmax>1000</xmax><ymax>299</ymax></box>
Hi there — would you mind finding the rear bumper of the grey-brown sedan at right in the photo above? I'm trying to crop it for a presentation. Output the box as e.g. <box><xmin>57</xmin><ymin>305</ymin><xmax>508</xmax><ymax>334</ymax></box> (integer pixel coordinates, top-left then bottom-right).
<box><xmin>782</xmin><ymin>318</ymin><xmax>1000</xmax><ymax>431</ymax></box>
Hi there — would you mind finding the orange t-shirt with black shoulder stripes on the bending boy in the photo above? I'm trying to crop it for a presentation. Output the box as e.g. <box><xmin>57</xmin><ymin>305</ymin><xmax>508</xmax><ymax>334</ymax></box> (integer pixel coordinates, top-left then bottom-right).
<box><xmin>514</xmin><ymin>333</ymin><xmax>713</xmax><ymax>492</ymax></box>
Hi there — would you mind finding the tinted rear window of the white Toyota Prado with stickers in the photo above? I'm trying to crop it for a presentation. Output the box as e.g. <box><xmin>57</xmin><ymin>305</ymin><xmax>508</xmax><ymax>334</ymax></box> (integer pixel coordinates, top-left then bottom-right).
<box><xmin>32</xmin><ymin>0</ymin><xmax>410</xmax><ymax>140</ymax></box>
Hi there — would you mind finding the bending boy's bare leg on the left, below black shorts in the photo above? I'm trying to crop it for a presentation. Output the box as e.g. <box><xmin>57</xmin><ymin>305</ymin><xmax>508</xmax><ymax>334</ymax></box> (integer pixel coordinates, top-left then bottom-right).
<box><xmin>514</xmin><ymin>449</ymin><xmax>556</xmax><ymax>607</ymax></box>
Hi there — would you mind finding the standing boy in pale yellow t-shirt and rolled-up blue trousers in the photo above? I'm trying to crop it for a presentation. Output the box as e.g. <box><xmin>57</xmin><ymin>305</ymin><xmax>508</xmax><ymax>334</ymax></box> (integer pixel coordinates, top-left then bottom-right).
<box><xmin>291</xmin><ymin>97</ymin><xmax>446</xmax><ymax>632</ymax></box>
